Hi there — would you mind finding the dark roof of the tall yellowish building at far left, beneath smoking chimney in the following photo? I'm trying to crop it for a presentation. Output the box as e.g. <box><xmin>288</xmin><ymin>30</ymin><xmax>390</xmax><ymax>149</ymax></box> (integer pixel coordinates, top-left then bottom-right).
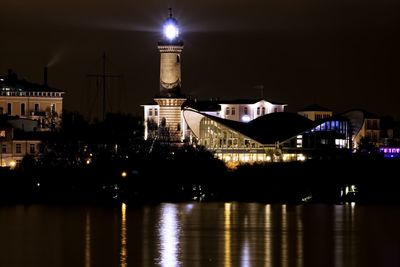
<box><xmin>0</xmin><ymin>71</ymin><xmax>64</xmax><ymax>93</ymax></box>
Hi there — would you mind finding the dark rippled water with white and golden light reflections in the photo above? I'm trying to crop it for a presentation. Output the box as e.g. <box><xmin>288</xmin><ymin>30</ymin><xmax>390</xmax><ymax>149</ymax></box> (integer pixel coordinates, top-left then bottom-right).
<box><xmin>0</xmin><ymin>202</ymin><xmax>400</xmax><ymax>267</ymax></box>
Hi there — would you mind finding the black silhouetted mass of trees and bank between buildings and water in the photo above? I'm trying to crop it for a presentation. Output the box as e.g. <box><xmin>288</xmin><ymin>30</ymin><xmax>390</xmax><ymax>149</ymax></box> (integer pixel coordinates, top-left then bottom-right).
<box><xmin>0</xmin><ymin>112</ymin><xmax>400</xmax><ymax>203</ymax></box>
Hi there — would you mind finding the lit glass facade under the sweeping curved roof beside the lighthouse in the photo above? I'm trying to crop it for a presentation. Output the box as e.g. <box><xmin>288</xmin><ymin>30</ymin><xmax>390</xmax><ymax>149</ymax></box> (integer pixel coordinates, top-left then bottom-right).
<box><xmin>185</xmin><ymin>108</ymin><xmax>351</xmax><ymax>162</ymax></box>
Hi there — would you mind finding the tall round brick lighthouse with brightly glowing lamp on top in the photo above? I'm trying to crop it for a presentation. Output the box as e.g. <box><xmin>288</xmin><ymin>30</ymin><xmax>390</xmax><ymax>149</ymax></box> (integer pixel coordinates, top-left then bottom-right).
<box><xmin>144</xmin><ymin>9</ymin><xmax>186</xmax><ymax>143</ymax></box>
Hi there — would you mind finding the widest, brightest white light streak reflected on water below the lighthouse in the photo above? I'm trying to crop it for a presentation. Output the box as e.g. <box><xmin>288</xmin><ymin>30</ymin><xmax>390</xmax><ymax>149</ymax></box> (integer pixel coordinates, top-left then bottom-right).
<box><xmin>158</xmin><ymin>204</ymin><xmax>180</xmax><ymax>267</ymax></box>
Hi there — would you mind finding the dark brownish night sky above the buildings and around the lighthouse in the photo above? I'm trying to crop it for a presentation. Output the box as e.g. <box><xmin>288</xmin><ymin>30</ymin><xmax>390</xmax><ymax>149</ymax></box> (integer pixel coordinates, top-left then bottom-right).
<box><xmin>0</xmin><ymin>0</ymin><xmax>400</xmax><ymax>119</ymax></box>
